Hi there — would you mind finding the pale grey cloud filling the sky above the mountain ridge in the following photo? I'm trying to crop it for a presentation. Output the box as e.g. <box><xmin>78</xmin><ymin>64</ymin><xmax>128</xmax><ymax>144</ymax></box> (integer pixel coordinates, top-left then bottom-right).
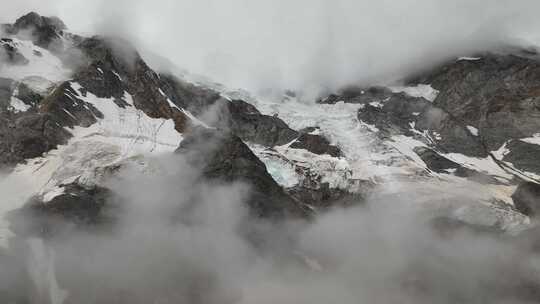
<box><xmin>0</xmin><ymin>0</ymin><xmax>540</xmax><ymax>93</ymax></box>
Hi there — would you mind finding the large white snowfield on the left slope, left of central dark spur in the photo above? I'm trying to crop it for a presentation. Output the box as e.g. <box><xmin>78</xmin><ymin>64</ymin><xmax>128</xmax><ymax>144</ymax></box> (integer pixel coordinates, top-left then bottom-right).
<box><xmin>0</xmin><ymin>82</ymin><xmax>183</xmax><ymax>247</ymax></box>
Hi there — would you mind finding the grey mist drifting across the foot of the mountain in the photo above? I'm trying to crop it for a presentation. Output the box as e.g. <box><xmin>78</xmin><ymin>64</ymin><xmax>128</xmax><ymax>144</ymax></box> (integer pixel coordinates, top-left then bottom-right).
<box><xmin>0</xmin><ymin>156</ymin><xmax>540</xmax><ymax>304</ymax></box>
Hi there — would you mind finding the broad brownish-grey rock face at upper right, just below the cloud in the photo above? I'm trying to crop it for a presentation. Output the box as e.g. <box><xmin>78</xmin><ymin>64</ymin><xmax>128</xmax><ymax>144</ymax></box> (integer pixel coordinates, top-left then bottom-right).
<box><xmin>419</xmin><ymin>54</ymin><xmax>540</xmax><ymax>151</ymax></box>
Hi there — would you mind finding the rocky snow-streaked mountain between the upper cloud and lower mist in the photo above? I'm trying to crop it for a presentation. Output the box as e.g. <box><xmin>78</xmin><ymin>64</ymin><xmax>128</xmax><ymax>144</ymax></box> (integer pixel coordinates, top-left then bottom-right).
<box><xmin>0</xmin><ymin>13</ymin><xmax>540</xmax><ymax>303</ymax></box>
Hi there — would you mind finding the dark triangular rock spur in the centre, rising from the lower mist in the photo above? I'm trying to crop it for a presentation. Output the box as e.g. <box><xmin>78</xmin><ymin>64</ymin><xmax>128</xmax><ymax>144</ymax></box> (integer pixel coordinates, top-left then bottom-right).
<box><xmin>177</xmin><ymin>128</ymin><xmax>305</xmax><ymax>218</ymax></box>
